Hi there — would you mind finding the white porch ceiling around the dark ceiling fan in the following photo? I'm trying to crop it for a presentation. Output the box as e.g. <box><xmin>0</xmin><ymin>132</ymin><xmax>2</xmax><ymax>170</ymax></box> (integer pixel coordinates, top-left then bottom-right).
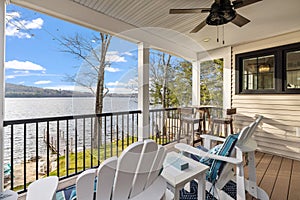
<box><xmin>11</xmin><ymin>0</ymin><xmax>300</xmax><ymax>59</ymax></box>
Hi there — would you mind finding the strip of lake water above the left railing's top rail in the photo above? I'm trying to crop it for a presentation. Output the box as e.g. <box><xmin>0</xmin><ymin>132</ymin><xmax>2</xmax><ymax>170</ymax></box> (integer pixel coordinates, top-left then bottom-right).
<box><xmin>5</xmin><ymin>97</ymin><xmax>137</xmax><ymax>120</ymax></box>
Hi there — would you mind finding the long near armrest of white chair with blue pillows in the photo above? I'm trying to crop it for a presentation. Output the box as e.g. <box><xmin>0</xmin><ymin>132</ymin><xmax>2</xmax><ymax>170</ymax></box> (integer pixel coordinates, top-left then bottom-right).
<box><xmin>175</xmin><ymin>143</ymin><xmax>243</xmax><ymax>165</ymax></box>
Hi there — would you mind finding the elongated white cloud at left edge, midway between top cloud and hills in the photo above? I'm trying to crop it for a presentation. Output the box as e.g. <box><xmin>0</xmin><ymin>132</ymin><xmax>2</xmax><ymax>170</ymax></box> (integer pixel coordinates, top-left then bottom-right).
<box><xmin>5</xmin><ymin>60</ymin><xmax>46</xmax><ymax>71</ymax></box>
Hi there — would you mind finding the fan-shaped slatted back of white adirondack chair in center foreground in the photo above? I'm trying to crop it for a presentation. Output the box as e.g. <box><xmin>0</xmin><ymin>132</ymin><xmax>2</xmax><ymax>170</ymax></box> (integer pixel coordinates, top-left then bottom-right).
<box><xmin>76</xmin><ymin>140</ymin><xmax>172</xmax><ymax>200</ymax></box>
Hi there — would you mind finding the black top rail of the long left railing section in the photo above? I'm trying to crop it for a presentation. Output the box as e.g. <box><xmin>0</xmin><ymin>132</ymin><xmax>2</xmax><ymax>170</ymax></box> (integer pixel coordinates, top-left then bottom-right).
<box><xmin>3</xmin><ymin>110</ymin><xmax>142</xmax><ymax>126</ymax></box>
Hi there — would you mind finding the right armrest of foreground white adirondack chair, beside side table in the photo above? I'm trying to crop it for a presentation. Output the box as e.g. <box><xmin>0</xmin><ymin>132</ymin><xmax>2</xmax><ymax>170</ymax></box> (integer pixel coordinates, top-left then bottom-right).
<box><xmin>130</xmin><ymin>176</ymin><xmax>167</xmax><ymax>200</ymax></box>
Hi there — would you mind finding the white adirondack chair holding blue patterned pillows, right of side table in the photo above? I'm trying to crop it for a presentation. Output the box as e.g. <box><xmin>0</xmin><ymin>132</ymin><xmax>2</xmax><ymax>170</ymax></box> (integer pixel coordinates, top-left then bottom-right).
<box><xmin>175</xmin><ymin>116</ymin><xmax>269</xmax><ymax>200</ymax></box>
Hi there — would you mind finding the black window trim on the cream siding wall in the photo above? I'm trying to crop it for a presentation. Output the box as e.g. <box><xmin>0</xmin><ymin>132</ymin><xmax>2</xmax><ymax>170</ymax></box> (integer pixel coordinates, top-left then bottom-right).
<box><xmin>235</xmin><ymin>43</ymin><xmax>300</xmax><ymax>94</ymax></box>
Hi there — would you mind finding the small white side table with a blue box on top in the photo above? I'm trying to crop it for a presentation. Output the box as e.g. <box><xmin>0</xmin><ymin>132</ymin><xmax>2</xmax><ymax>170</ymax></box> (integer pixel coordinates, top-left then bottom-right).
<box><xmin>162</xmin><ymin>152</ymin><xmax>209</xmax><ymax>200</ymax></box>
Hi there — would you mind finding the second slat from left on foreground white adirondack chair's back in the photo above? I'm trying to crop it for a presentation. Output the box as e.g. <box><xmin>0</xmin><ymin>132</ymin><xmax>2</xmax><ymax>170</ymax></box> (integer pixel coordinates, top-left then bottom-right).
<box><xmin>96</xmin><ymin>157</ymin><xmax>118</xmax><ymax>200</ymax></box>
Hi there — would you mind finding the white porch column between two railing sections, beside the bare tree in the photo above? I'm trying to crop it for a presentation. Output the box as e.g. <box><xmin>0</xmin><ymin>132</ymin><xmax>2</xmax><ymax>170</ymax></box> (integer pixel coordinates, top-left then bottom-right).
<box><xmin>138</xmin><ymin>43</ymin><xmax>150</xmax><ymax>141</ymax></box>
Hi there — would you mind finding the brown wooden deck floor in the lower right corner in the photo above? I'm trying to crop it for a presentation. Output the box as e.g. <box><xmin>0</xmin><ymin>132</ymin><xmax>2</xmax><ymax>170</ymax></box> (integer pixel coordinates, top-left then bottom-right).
<box><xmin>245</xmin><ymin>152</ymin><xmax>300</xmax><ymax>200</ymax></box>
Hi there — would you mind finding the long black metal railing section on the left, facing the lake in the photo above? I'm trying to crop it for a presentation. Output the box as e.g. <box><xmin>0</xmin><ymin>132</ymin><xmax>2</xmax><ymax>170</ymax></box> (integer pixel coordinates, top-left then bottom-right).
<box><xmin>4</xmin><ymin>111</ymin><xmax>141</xmax><ymax>193</ymax></box>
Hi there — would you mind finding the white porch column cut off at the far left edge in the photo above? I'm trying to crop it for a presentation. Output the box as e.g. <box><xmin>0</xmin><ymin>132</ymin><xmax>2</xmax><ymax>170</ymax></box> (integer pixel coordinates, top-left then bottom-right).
<box><xmin>0</xmin><ymin>0</ymin><xmax>6</xmax><ymax>192</ymax></box>
